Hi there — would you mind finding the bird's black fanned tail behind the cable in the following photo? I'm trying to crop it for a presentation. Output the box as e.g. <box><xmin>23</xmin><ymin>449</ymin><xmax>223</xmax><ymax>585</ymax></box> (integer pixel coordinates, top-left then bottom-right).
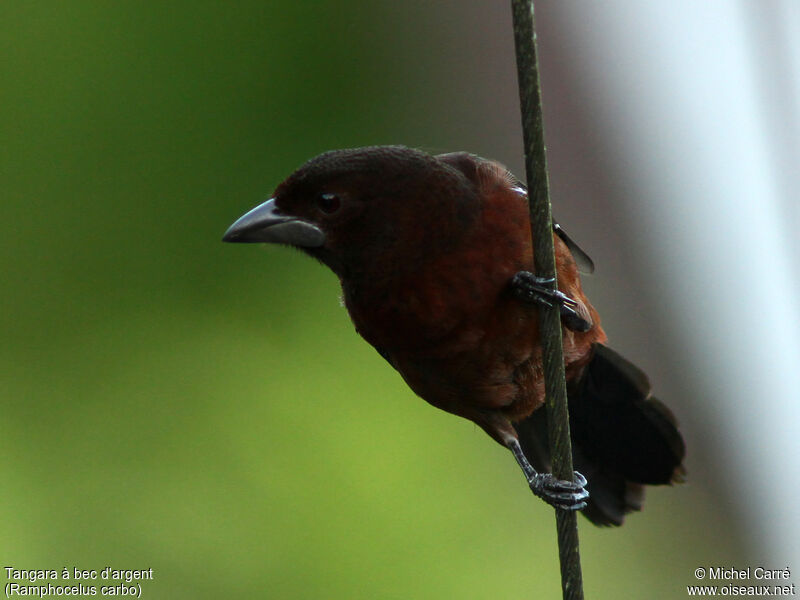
<box><xmin>515</xmin><ymin>344</ymin><xmax>686</xmax><ymax>525</ymax></box>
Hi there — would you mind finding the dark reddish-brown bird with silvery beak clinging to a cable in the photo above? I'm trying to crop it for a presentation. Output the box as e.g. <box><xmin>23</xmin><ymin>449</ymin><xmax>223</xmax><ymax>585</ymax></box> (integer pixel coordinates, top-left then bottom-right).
<box><xmin>223</xmin><ymin>146</ymin><xmax>686</xmax><ymax>526</ymax></box>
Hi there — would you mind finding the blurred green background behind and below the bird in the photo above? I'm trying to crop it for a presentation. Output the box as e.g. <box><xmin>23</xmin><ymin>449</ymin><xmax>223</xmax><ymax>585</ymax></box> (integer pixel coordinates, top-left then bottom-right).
<box><xmin>0</xmin><ymin>1</ymin><xmax>741</xmax><ymax>599</ymax></box>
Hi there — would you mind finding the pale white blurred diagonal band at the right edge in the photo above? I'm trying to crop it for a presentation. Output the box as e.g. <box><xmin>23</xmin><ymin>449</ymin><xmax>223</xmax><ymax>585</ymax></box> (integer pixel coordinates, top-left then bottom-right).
<box><xmin>558</xmin><ymin>0</ymin><xmax>800</xmax><ymax>569</ymax></box>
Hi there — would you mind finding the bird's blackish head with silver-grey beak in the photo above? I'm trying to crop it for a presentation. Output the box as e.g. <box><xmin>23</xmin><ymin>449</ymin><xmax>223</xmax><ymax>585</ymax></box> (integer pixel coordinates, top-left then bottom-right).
<box><xmin>223</xmin><ymin>146</ymin><xmax>480</xmax><ymax>279</ymax></box>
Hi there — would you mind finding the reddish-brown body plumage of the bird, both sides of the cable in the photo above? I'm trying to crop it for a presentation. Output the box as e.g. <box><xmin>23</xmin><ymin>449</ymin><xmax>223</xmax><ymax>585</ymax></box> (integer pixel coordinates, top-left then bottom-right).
<box><xmin>345</xmin><ymin>155</ymin><xmax>606</xmax><ymax>443</ymax></box>
